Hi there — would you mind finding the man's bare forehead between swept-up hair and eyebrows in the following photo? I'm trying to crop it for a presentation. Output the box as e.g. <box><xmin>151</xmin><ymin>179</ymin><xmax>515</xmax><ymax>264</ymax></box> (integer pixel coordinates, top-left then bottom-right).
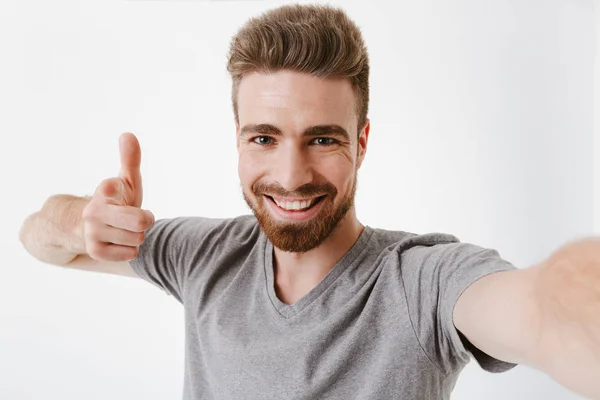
<box><xmin>238</xmin><ymin>71</ymin><xmax>357</xmax><ymax>125</ymax></box>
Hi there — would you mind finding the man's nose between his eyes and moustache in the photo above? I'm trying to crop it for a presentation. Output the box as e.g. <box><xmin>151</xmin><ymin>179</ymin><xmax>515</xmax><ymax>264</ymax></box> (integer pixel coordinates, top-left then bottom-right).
<box><xmin>275</xmin><ymin>143</ymin><xmax>314</xmax><ymax>192</ymax></box>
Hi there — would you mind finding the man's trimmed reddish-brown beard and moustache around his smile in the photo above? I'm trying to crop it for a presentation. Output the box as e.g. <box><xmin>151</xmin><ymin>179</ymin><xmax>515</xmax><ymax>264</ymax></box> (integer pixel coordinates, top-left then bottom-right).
<box><xmin>243</xmin><ymin>174</ymin><xmax>357</xmax><ymax>253</ymax></box>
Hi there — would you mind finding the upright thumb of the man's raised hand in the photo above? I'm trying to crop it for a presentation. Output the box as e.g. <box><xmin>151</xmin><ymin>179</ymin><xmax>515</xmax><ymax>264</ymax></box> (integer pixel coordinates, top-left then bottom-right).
<box><xmin>119</xmin><ymin>132</ymin><xmax>143</xmax><ymax>207</ymax></box>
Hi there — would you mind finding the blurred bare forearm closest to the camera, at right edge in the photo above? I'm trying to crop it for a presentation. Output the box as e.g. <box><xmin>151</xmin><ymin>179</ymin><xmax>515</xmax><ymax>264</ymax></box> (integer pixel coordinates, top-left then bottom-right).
<box><xmin>537</xmin><ymin>239</ymin><xmax>600</xmax><ymax>399</ymax></box>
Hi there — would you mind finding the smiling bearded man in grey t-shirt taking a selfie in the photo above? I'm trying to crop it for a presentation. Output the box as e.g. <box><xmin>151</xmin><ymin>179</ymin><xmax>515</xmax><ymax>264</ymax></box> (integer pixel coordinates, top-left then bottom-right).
<box><xmin>20</xmin><ymin>6</ymin><xmax>600</xmax><ymax>399</ymax></box>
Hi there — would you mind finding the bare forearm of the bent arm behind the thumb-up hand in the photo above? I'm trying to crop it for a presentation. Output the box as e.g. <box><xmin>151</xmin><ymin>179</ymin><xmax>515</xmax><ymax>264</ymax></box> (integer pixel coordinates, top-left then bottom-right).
<box><xmin>19</xmin><ymin>195</ymin><xmax>90</xmax><ymax>265</ymax></box>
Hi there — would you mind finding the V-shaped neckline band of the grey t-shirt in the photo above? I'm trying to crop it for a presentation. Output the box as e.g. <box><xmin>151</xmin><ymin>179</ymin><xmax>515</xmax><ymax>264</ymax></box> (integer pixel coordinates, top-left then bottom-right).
<box><xmin>261</xmin><ymin>225</ymin><xmax>373</xmax><ymax>318</ymax></box>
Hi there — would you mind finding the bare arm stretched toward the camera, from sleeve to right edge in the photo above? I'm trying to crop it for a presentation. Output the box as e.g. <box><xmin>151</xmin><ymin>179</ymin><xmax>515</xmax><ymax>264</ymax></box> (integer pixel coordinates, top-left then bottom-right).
<box><xmin>454</xmin><ymin>238</ymin><xmax>600</xmax><ymax>399</ymax></box>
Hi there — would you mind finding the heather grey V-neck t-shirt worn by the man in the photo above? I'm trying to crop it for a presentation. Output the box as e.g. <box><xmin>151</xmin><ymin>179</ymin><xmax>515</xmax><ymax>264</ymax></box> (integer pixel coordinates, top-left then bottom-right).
<box><xmin>130</xmin><ymin>215</ymin><xmax>515</xmax><ymax>400</ymax></box>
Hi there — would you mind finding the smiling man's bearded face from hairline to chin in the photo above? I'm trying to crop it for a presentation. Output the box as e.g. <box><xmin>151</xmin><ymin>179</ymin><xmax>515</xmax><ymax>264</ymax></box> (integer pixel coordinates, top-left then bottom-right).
<box><xmin>236</xmin><ymin>71</ymin><xmax>369</xmax><ymax>253</ymax></box>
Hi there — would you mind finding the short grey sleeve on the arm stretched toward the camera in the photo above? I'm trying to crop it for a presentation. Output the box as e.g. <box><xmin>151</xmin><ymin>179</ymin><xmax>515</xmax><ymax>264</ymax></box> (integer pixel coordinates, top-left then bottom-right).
<box><xmin>402</xmin><ymin>242</ymin><xmax>516</xmax><ymax>373</ymax></box>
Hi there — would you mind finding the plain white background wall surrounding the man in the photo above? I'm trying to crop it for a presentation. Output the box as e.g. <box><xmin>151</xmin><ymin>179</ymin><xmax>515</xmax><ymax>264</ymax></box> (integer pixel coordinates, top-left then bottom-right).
<box><xmin>0</xmin><ymin>0</ymin><xmax>600</xmax><ymax>400</ymax></box>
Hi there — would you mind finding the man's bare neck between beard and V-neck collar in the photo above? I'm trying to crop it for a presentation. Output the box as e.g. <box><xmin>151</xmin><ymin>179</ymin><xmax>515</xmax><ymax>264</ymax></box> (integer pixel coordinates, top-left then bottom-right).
<box><xmin>274</xmin><ymin>208</ymin><xmax>364</xmax><ymax>304</ymax></box>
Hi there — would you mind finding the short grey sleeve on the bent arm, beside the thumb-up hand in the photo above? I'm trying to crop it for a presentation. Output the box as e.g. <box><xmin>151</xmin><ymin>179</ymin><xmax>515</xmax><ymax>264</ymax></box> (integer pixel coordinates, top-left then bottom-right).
<box><xmin>129</xmin><ymin>217</ymin><xmax>222</xmax><ymax>303</ymax></box>
